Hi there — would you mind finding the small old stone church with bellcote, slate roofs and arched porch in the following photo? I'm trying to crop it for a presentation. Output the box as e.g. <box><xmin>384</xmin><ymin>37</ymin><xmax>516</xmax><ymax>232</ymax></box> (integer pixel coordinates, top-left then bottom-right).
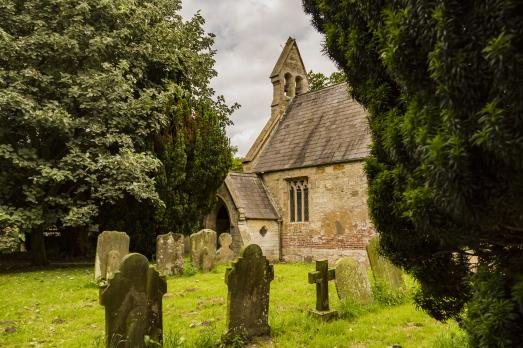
<box><xmin>204</xmin><ymin>38</ymin><xmax>375</xmax><ymax>263</ymax></box>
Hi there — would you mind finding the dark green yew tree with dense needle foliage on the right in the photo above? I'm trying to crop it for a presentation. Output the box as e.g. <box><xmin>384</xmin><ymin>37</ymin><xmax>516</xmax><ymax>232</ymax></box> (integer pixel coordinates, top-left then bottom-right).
<box><xmin>303</xmin><ymin>0</ymin><xmax>523</xmax><ymax>346</ymax></box>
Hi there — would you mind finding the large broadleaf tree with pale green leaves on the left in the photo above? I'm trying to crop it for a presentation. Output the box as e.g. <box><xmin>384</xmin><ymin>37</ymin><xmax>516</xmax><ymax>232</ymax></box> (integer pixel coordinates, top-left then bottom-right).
<box><xmin>0</xmin><ymin>0</ymin><xmax>234</xmax><ymax>264</ymax></box>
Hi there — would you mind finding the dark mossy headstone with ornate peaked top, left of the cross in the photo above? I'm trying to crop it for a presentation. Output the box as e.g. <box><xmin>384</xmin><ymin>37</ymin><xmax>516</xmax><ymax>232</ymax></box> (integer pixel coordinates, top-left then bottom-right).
<box><xmin>225</xmin><ymin>244</ymin><xmax>274</xmax><ymax>340</ymax></box>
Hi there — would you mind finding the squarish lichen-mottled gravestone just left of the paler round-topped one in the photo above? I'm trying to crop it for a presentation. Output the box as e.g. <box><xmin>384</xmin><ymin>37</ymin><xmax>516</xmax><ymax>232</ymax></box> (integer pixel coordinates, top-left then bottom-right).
<box><xmin>156</xmin><ymin>233</ymin><xmax>184</xmax><ymax>276</ymax></box>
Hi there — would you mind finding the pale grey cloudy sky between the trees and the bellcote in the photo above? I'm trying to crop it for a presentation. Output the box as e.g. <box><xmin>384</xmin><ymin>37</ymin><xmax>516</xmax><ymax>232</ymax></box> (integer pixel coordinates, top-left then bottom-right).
<box><xmin>182</xmin><ymin>0</ymin><xmax>336</xmax><ymax>156</ymax></box>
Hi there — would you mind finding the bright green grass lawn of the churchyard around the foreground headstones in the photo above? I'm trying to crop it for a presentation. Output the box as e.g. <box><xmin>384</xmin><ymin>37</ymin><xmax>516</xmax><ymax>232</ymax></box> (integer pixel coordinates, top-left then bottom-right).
<box><xmin>0</xmin><ymin>264</ymin><xmax>465</xmax><ymax>348</ymax></box>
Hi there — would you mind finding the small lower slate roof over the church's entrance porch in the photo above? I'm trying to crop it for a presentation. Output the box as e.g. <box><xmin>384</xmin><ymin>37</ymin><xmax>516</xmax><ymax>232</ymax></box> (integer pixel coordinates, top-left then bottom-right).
<box><xmin>225</xmin><ymin>173</ymin><xmax>278</xmax><ymax>220</ymax></box>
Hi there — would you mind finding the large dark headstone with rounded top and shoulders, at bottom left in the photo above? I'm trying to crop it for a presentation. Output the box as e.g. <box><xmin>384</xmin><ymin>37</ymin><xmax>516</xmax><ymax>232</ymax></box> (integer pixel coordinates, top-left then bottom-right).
<box><xmin>100</xmin><ymin>253</ymin><xmax>167</xmax><ymax>348</ymax></box>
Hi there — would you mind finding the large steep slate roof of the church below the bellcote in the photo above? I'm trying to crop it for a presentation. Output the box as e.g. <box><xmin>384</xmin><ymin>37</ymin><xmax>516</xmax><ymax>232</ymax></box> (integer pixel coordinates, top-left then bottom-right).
<box><xmin>252</xmin><ymin>83</ymin><xmax>371</xmax><ymax>173</ymax></box>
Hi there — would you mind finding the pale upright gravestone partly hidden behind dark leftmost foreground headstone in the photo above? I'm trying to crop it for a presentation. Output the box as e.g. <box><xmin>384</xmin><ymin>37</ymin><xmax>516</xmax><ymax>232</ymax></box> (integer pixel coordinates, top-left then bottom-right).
<box><xmin>94</xmin><ymin>231</ymin><xmax>129</xmax><ymax>281</ymax></box>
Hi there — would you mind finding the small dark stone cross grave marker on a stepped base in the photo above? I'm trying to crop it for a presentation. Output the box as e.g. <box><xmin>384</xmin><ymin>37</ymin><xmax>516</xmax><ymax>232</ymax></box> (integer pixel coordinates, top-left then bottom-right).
<box><xmin>309</xmin><ymin>260</ymin><xmax>338</xmax><ymax>320</ymax></box>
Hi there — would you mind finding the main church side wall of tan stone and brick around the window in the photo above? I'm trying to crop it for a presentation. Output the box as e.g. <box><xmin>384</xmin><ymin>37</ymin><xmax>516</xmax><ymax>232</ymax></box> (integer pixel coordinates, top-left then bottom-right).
<box><xmin>263</xmin><ymin>161</ymin><xmax>375</xmax><ymax>264</ymax></box>
